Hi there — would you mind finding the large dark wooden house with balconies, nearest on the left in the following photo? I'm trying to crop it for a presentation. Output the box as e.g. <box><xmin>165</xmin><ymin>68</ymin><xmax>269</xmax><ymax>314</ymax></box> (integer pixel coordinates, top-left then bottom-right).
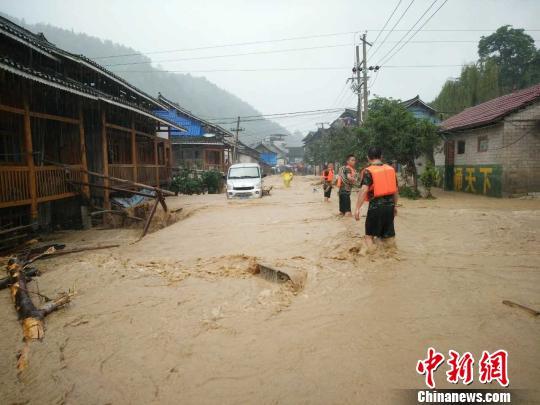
<box><xmin>0</xmin><ymin>17</ymin><xmax>184</xmax><ymax>228</ymax></box>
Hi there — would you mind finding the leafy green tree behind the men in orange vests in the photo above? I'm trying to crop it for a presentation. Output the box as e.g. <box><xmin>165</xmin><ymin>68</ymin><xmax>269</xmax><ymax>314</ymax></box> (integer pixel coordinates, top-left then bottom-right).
<box><xmin>359</xmin><ymin>98</ymin><xmax>440</xmax><ymax>189</ymax></box>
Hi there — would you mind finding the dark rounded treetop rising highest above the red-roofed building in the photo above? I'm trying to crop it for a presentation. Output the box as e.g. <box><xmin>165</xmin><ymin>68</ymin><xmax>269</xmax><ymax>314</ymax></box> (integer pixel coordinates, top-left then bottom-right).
<box><xmin>478</xmin><ymin>25</ymin><xmax>539</xmax><ymax>93</ymax></box>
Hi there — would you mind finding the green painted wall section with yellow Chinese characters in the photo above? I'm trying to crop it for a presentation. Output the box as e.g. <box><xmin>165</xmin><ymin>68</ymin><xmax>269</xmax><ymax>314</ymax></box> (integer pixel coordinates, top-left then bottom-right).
<box><xmin>436</xmin><ymin>164</ymin><xmax>502</xmax><ymax>197</ymax></box>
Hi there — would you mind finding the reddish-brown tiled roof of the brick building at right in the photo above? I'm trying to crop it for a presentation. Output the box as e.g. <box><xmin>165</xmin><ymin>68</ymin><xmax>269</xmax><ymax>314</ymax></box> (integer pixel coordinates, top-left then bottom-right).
<box><xmin>441</xmin><ymin>84</ymin><xmax>540</xmax><ymax>132</ymax></box>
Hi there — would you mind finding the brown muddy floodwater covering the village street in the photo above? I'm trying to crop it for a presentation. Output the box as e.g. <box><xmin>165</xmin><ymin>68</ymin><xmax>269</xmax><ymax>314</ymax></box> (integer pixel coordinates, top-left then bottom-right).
<box><xmin>0</xmin><ymin>177</ymin><xmax>540</xmax><ymax>404</ymax></box>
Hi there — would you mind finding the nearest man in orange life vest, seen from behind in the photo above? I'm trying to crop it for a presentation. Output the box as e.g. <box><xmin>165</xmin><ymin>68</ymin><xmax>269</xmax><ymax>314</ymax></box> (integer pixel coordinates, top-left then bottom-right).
<box><xmin>354</xmin><ymin>147</ymin><xmax>398</xmax><ymax>247</ymax></box>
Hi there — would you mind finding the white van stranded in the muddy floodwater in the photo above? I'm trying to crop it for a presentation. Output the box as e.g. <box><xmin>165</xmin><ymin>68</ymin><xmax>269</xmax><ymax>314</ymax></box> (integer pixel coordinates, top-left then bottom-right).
<box><xmin>227</xmin><ymin>163</ymin><xmax>266</xmax><ymax>198</ymax></box>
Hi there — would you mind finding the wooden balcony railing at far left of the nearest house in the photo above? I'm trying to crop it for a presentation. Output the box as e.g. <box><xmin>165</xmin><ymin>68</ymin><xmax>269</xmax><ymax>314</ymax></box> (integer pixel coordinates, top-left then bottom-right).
<box><xmin>0</xmin><ymin>165</ymin><xmax>82</xmax><ymax>208</ymax></box>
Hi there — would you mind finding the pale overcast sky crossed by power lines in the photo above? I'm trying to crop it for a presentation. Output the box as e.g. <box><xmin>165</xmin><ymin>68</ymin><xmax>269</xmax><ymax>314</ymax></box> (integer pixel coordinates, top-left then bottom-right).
<box><xmin>0</xmin><ymin>0</ymin><xmax>540</xmax><ymax>131</ymax></box>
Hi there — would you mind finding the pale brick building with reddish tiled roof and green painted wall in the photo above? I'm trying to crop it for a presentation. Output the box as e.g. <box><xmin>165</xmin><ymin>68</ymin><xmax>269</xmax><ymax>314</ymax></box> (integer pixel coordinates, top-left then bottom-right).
<box><xmin>435</xmin><ymin>84</ymin><xmax>540</xmax><ymax>197</ymax></box>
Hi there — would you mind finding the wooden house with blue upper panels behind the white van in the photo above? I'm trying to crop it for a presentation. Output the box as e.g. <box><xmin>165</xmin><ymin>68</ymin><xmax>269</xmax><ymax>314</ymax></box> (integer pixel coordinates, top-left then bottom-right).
<box><xmin>154</xmin><ymin>94</ymin><xmax>233</xmax><ymax>172</ymax></box>
